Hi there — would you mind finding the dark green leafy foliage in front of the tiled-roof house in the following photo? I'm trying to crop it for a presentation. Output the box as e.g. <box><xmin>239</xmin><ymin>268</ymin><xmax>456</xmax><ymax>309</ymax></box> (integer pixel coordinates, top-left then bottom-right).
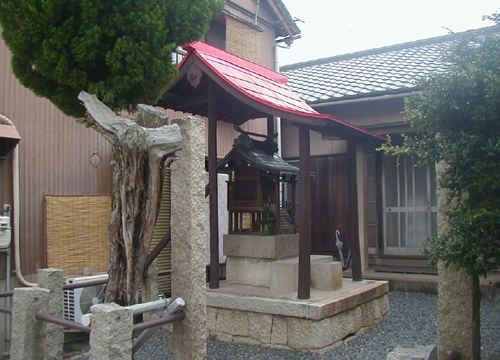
<box><xmin>383</xmin><ymin>28</ymin><xmax>500</xmax><ymax>275</ymax></box>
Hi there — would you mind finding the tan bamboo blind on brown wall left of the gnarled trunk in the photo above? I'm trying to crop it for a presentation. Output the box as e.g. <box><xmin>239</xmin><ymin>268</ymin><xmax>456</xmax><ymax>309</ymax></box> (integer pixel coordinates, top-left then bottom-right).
<box><xmin>45</xmin><ymin>195</ymin><xmax>111</xmax><ymax>276</ymax></box>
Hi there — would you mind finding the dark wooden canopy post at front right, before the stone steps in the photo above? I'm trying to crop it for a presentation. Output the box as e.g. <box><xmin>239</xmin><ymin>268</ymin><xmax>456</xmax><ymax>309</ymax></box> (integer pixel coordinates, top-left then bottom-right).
<box><xmin>298</xmin><ymin>126</ymin><xmax>312</xmax><ymax>299</ymax></box>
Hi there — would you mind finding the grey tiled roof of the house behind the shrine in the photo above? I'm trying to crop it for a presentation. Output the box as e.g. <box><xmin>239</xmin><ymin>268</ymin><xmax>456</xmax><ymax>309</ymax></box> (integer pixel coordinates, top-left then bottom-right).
<box><xmin>281</xmin><ymin>26</ymin><xmax>500</xmax><ymax>105</ymax></box>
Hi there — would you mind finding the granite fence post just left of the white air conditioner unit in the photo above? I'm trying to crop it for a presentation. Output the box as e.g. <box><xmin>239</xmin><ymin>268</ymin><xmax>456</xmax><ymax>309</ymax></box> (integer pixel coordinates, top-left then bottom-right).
<box><xmin>38</xmin><ymin>268</ymin><xmax>64</xmax><ymax>360</ymax></box>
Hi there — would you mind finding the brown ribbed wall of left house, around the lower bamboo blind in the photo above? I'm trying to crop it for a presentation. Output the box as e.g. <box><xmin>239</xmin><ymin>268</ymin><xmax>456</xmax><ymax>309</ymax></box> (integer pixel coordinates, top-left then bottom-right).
<box><xmin>0</xmin><ymin>31</ymin><xmax>111</xmax><ymax>274</ymax></box>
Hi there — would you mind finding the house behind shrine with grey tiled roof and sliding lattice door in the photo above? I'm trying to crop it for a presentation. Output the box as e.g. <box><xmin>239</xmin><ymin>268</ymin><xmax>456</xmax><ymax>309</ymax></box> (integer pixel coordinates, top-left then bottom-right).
<box><xmin>281</xmin><ymin>26</ymin><xmax>499</xmax><ymax>269</ymax></box>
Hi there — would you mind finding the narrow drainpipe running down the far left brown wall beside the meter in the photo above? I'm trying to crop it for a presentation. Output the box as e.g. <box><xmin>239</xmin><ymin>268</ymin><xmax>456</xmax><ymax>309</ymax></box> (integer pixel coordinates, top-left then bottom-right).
<box><xmin>0</xmin><ymin>114</ymin><xmax>38</xmax><ymax>287</ymax></box>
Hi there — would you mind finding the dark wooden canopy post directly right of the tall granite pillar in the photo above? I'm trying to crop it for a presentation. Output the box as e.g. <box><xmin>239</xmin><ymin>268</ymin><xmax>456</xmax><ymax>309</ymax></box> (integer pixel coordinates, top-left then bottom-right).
<box><xmin>208</xmin><ymin>84</ymin><xmax>219</xmax><ymax>289</ymax></box>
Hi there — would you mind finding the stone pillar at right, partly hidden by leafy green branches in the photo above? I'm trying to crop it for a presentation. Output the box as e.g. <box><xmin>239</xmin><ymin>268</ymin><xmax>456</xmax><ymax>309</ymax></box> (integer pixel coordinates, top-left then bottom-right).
<box><xmin>436</xmin><ymin>163</ymin><xmax>481</xmax><ymax>360</ymax></box>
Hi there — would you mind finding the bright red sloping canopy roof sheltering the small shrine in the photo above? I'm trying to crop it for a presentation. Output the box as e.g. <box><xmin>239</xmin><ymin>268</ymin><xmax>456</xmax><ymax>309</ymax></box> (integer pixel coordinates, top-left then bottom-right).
<box><xmin>158</xmin><ymin>41</ymin><xmax>386</xmax><ymax>142</ymax></box>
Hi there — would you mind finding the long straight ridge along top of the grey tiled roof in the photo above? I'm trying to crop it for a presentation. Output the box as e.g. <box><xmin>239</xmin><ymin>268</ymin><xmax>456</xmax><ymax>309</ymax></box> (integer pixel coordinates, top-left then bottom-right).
<box><xmin>280</xmin><ymin>25</ymin><xmax>500</xmax><ymax>72</ymax></box>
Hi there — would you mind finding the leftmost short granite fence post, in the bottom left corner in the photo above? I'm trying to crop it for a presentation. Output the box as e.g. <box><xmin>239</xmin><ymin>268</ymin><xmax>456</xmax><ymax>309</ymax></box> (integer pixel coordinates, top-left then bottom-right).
<box><xmin>10</xmin><ymin>287</ymin><xmax>50</xmax><ymax>360</ymax></box>
